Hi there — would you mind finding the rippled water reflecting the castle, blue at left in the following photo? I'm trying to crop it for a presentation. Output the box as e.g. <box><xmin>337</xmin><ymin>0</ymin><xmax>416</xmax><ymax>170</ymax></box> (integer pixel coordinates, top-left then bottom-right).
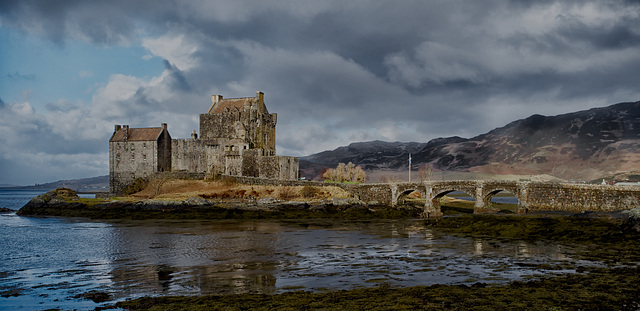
<box><xmin>0</xmin><ymin>190</ymin><xmax>588</xmax><ymax>310</ymax></box>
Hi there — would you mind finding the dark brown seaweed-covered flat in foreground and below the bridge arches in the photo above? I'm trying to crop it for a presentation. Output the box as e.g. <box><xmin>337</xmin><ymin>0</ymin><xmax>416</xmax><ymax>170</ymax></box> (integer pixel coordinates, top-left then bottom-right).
<box><xmin>109</xmin><ymin>214</ymin><xmax>640</xmax><ymax>310</ymax></box>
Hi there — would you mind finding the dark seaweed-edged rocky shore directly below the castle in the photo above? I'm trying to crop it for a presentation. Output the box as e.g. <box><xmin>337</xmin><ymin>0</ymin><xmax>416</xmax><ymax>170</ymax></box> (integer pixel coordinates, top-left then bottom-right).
<box><xmin>17</xmin><ymin>188</ymin><xmax>422</xmax><ymax>219</ymax></box>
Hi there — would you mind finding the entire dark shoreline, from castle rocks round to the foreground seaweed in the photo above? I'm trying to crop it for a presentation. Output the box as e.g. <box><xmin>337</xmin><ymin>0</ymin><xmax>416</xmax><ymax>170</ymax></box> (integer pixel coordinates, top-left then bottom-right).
<box><xmin>13</xmin><ymin>190</ymin><xmax>640</xmax><ymax>310</ymax></box>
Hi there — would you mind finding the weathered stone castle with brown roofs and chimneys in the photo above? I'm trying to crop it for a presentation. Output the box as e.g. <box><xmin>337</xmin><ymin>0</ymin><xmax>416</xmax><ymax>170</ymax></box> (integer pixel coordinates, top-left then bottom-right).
<box><xmin>109</xmin><ymin>92</ymin><xmax>298</xmax><ymax>193</ymax></box>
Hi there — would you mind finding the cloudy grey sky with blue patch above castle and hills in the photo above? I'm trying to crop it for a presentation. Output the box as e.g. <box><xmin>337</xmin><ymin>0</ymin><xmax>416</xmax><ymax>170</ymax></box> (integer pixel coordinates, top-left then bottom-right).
<box><xmin>0</xmin><ymin>0</ymin><xmax>640</xmax><ymax>185</ymax></box>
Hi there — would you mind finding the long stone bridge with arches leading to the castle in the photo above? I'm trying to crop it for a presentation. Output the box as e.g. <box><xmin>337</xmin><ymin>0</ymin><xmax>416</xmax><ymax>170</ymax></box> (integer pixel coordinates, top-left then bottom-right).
<box><xmin>228</xmin><ymin>177</ymin><xmax>640</xmax><ymax>217</ymax></box>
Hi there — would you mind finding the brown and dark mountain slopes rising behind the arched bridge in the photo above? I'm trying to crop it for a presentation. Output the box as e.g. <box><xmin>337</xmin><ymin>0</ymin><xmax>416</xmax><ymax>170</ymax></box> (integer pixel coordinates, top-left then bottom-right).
<box><xmin>300</xmin><ymin>101</ymin><xmax>640</xmax><ymax>180</ymax></box>
